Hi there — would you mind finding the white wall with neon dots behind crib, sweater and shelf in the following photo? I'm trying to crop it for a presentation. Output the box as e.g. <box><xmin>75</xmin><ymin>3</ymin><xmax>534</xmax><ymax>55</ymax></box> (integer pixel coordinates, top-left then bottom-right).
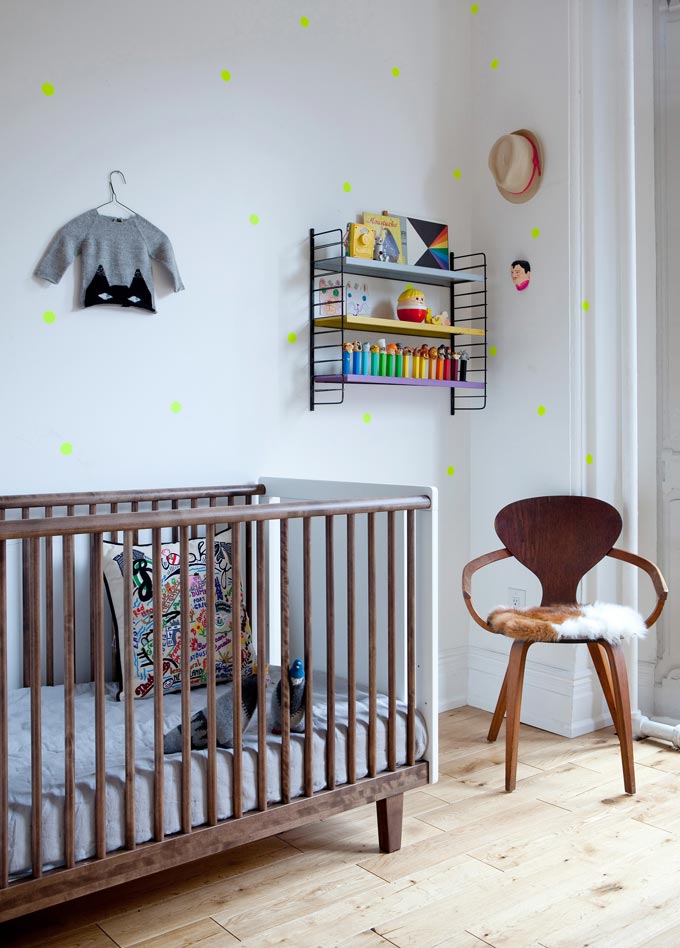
<box><xmin>0</xmin><ymin>0</ymin><xmax>472</xmax><ymax>703</ymax></box>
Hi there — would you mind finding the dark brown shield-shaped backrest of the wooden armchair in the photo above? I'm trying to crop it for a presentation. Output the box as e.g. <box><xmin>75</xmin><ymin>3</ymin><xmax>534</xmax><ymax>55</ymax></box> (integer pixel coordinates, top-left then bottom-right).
<box><xmin>494</xmin><ymin>496</ymin><xmax>623</xmax><ymax>606</ymax></box>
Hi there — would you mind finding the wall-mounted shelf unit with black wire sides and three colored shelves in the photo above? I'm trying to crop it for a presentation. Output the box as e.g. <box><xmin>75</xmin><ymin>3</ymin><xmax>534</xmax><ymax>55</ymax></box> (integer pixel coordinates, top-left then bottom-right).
<box><xmin>309</xmin><ymin>228</ymin><xmax>486</xmax><ymax>414</ymax></box>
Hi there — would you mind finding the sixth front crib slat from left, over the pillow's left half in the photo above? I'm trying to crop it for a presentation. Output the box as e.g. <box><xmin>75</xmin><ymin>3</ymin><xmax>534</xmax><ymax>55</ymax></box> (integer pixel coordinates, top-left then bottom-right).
<box><xmin>151</xmin><ymin>527</ymin><xmax>165</xmax><ymax>842</ymax></box>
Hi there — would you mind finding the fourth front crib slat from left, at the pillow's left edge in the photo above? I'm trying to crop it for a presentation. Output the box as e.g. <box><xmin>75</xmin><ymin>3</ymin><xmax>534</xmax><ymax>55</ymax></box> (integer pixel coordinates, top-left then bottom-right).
<box><xmin>92</xmin><ymin>533</ymin><xmax>106</xmax><ymax>859</ymax></box>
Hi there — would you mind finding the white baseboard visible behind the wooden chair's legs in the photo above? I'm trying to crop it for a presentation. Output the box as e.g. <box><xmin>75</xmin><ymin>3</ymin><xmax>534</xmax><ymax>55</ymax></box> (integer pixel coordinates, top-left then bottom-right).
<box><xmin>468</xmin><ymin>646</ymin><xmax>611</xmax><ymax>737</ymax></box>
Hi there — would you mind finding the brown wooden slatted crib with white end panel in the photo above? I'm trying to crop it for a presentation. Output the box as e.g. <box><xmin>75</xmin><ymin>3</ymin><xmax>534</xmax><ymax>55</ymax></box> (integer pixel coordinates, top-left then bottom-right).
<box><xmin>0</xmin><ymin>484</ymin><xmax>436</xmax><ymax>921</ymax></box>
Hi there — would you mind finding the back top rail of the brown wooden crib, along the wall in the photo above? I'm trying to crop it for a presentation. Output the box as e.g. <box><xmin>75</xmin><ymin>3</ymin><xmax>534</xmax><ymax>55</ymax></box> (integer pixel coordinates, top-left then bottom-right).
<box><xmin>0</xmin><ymin>484</ymin><xmax>266</xmax><ymax>511</ymax></box>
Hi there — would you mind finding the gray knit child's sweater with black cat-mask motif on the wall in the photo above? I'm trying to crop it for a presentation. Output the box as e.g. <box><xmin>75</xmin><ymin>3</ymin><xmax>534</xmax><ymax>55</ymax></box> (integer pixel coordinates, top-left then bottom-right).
<box><xmin>35</xmin><ymin>210</ymin><xmax>184</xmax><ymax>313</ymax></box>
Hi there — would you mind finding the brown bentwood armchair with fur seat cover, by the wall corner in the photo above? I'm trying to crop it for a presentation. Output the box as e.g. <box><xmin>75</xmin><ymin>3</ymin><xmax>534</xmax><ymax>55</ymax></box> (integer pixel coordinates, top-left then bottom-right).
<box><xmin>463</xmin><ymin>496</ymin><xmax>668</xmax><ymax>793</ymax></box>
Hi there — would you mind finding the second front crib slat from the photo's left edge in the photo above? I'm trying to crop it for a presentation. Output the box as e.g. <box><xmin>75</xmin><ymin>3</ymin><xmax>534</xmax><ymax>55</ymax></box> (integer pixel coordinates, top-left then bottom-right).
<box><xmin>28</xmin><ymin>537</ymin><xmax>42</xmax><ymax>878</ymax></box>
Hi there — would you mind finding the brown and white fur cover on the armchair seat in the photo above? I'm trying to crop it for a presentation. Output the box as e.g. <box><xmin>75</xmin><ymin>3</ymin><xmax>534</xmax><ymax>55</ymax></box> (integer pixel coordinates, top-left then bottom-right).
<box><xmin>487</xmin><ymin>602</ymin><xmax>647</xmax><ymax>643</ymax></box>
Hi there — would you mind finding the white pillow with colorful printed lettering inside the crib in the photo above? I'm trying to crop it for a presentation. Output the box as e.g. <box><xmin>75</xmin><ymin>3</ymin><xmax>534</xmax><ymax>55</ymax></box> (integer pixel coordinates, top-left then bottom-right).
<box><xmin>104</xmin><ymin>530</ymin><xmax>255</xmax><ymax>698</ymax></box>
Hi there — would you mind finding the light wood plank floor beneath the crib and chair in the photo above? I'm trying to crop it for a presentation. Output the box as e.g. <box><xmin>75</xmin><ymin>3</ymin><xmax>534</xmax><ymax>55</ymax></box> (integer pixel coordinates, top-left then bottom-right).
<box><xmin>0</xmin><ymin>708</ymin><xmax>680</xmax><ymax>948</ymax></box>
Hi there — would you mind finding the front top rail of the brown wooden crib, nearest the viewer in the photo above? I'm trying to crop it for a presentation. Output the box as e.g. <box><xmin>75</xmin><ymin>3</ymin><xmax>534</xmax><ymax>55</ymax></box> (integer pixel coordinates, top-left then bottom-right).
<box><xmin>0</xmin><ymin>495</ymin><xmax>431</xmax><ymax>541</ymax></box>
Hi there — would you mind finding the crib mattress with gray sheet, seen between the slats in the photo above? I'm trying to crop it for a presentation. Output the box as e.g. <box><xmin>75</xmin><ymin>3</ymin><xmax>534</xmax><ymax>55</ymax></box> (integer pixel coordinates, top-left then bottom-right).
<box><xmin>8</xmin><ymin>669</ymin><xmax>427</xmax><ymax>877</ymax></box>
